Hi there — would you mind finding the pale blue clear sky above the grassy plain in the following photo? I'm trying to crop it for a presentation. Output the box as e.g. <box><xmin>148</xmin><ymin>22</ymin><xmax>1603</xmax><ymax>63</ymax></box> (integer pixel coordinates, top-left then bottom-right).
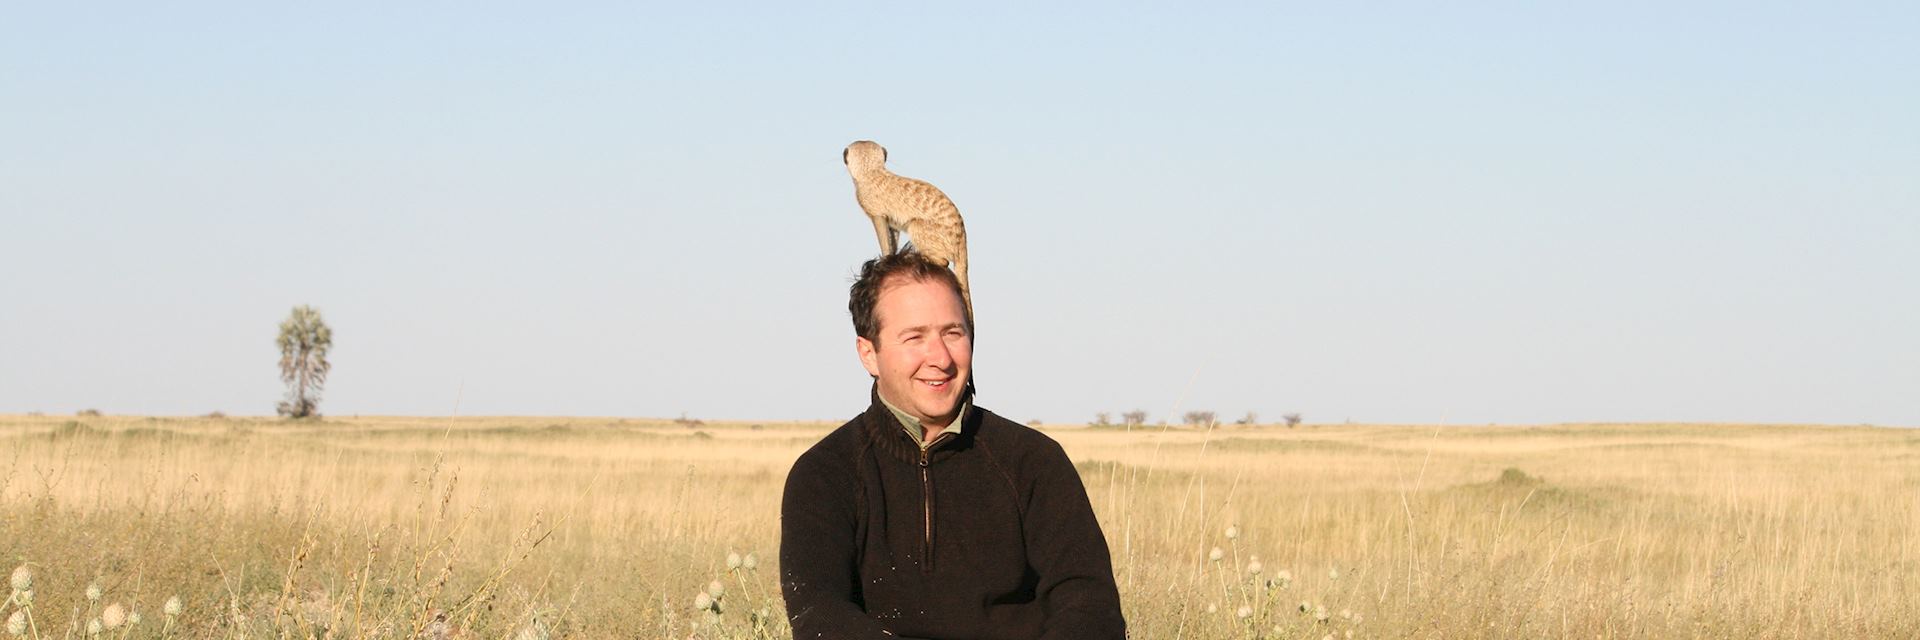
<box><xmin>0</xmin><ymin>2</ymin><xmax>1920</xmax><ymax>427</ymax></box>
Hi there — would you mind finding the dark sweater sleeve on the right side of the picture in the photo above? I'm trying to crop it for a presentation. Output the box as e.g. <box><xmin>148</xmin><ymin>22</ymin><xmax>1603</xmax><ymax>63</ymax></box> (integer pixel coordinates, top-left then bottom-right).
<box><xmin>1025</xmin><ymin>436</ymin><xmax>1127</xmax><ymax>640</ymax></box>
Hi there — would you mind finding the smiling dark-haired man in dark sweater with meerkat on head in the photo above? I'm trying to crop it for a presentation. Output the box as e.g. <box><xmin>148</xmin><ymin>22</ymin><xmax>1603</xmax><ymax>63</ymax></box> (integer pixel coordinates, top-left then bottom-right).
<box><xmin>780</xmin><ymin>254</ymin><xmax>1127</xmax><ymax>640</ymax></box>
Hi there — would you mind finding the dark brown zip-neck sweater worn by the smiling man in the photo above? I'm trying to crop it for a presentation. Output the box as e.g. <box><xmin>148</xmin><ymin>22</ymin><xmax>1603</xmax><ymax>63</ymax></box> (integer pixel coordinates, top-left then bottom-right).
<box><xmin>780</xmin><ymin>386</ymin><xmax>1127</xmax><ymax>640</ymax></box>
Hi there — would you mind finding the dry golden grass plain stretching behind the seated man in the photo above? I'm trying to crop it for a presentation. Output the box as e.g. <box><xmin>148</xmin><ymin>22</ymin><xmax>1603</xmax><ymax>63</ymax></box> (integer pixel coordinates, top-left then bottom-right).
<box><xmin>0</xmin><ymin>415</ymin><xmax>1920</xmax><ymax>640</ymax></box>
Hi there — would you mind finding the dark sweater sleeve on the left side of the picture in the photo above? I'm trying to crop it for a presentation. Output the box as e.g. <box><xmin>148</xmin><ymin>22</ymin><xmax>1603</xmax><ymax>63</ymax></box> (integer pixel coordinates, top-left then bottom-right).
<box><xmin>780</xmin><ymin>450</ymin><xmax>893</xmax><ymax>640</ymax></box>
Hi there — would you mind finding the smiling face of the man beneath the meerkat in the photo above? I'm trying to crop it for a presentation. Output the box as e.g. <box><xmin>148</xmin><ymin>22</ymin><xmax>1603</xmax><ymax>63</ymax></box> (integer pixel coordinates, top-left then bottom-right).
<box><xmin>854</xmin><ymin>281</ymin><xmax>973</xmax><ymax>429</ymax></box>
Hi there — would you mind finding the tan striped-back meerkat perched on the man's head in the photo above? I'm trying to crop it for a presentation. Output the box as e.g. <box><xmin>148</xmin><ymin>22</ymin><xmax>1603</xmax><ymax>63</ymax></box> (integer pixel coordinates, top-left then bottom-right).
<box><xmin>841</xmin><ymin>140</ymin><xmax>973</xmax><ymax>317</ymax></box>
